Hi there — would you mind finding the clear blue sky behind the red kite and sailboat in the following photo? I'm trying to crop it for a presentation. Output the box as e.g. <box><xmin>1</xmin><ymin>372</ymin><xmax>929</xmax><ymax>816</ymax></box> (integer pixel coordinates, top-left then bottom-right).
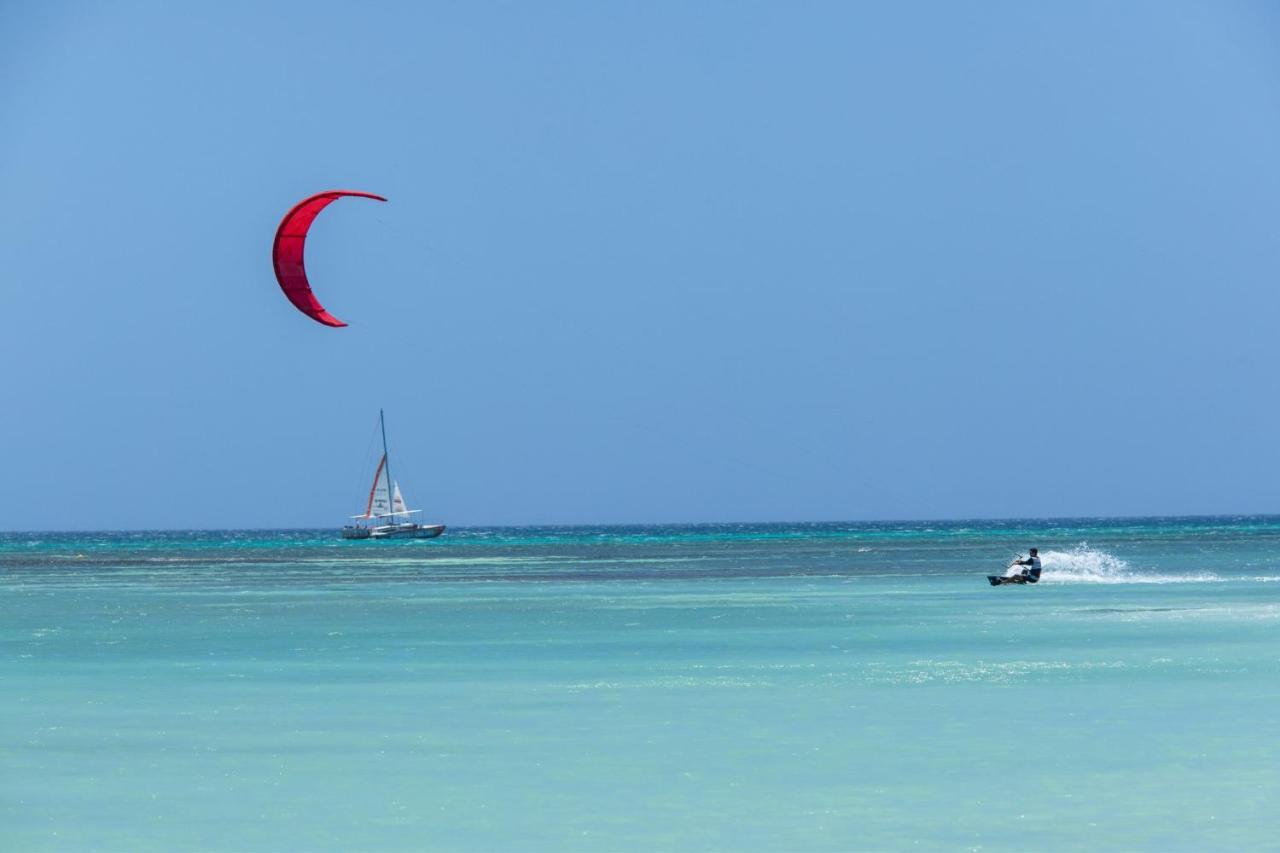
<box><xmin>0</xmin><ymin>0</ymin><xmax>1280</xmax><ymax>530</ymax></box>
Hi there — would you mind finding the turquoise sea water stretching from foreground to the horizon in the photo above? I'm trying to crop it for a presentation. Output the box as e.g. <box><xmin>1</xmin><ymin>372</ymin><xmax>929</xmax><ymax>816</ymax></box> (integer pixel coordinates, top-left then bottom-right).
<box><xmin>0</xmin><ymin>517</ymin><xmax>1280</xmax><ymax>850</ymax></box>
